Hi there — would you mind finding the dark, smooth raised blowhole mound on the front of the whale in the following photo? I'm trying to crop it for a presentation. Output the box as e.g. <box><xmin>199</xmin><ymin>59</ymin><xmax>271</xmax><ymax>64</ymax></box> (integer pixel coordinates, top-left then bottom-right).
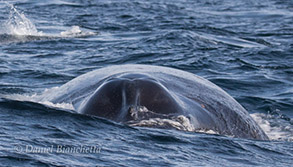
<box><xmin>79</xmin><ymin>73</ymin><xmax>181</xmax><ymax>122</ymax></box>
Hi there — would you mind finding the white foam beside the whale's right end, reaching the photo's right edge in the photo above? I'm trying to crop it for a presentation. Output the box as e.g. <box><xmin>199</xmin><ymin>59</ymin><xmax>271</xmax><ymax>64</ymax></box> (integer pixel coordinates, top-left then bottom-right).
<box><xmin>250</xmin><ymin>113</ymin><xmax>293</xmax><ymax>141</ymax></box>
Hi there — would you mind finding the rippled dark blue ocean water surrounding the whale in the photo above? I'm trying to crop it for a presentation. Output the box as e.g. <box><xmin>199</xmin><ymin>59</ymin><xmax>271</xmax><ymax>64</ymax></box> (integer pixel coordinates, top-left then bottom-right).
<box><xmin>0</xmin><ymin>0</ymin><xmax>293</xmax><ymax>167</ymax></box>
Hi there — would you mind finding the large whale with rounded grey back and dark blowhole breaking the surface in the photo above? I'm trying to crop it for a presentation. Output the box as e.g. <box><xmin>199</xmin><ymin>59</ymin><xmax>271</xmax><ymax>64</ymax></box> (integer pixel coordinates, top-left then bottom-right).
<box><xmin>41</xmin><ymin>64</ymin><xmax>268</xmax><ymax>140</ymax></box>
